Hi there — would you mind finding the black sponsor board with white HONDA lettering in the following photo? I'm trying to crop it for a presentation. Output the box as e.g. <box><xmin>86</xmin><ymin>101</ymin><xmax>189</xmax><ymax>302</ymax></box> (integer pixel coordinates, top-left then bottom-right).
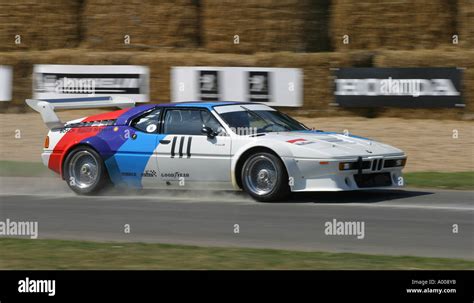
<box><xmin>334</xmin><ymin>67</ymin><xmax>465</xmax><ymax>108</ymax></box>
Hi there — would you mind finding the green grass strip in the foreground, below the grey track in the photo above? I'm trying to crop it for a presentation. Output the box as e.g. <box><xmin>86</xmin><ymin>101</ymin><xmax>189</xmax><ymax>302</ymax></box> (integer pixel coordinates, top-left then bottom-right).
<box><xmin>0</xmin><ymin>238</ymin><xmax>474</xmax><ymax>270</ymax></box>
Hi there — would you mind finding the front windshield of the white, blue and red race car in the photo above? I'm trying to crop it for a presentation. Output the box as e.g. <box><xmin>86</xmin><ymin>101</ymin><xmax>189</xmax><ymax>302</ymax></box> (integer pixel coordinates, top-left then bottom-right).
<box><xmin>217</xmin><ymin>105</ymin><xmax>309</xmax><ymax>135</ymax></box>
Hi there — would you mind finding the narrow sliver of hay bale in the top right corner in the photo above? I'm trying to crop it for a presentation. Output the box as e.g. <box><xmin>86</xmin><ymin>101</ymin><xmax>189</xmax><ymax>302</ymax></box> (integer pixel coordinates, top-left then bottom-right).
<box><xmin>457</xmin><ymin>0</ymin><xmax>474</xmax><ymax>48</ymax></box>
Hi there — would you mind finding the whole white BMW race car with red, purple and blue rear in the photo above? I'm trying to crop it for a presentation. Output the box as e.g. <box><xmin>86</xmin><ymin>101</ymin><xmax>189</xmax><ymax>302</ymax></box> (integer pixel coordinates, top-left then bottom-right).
<box><xmin>26</xmin><ymin>97</ymin><xmax>406</xmax><ymax>201</ymax></box>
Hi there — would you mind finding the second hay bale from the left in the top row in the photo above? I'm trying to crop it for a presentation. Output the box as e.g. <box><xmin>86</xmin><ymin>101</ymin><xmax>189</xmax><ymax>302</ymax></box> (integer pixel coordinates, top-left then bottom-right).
<box><xmin>82</xmin><ymin>0</ymin><xmax>199</xmax><ymax>50</ymax></box>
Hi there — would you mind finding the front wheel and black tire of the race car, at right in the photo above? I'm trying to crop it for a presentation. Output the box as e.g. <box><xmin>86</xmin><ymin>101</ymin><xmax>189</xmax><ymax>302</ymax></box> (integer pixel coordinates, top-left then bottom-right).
<box><xmin>241</xmin><ymin>152</ymin><xmax>290</xmax><ymax>202</ymax></box>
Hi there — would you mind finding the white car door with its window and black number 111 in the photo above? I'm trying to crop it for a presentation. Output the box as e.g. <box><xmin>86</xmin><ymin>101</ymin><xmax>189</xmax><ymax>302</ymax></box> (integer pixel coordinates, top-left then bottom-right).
<box><xmin>157</xmin><ymin>107</ymin><xmax>232</xmax><ymax>188</ymax></box>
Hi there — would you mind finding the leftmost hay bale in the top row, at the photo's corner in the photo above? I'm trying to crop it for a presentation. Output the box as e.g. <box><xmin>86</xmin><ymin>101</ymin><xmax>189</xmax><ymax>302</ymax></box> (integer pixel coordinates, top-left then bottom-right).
<box><xmin>0</xmin><ymin>0</ymin><xmax>81</xmax><ymax>51</ymax></box>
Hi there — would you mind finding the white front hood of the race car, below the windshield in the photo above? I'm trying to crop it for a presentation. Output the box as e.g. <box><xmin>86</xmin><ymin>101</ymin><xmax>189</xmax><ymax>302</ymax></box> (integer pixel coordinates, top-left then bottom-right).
<box><xmin>264</xmin><ymin>131</ymin><xmax>404</xmax><ymax>158</ymax></box>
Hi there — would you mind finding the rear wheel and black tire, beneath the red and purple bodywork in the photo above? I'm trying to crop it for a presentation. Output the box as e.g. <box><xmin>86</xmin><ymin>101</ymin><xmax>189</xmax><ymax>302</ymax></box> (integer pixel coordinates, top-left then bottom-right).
<box><xmin>63</xmin><ymin>146</ymin><xmax>110</xmax><ymax>195</ymax></box>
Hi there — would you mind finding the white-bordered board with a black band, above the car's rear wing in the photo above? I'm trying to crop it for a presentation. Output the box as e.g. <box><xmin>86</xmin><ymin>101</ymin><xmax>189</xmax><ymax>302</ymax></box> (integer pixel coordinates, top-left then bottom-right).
<box><xmin>33</xmin><ymin>64</ymin><xmax>149</xmax><ymax>102</ymax></box>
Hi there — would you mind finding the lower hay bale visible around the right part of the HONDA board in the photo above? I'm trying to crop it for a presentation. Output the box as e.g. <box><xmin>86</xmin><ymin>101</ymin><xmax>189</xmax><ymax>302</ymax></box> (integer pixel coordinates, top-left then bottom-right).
<box><xmin>374</xmin><ymin>50</ymin><xmax>474</xmax><ymax>119</ymax></box>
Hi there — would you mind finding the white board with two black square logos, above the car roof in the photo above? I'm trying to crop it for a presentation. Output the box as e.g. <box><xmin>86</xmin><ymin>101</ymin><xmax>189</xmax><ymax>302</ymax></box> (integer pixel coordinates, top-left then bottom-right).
<box><xmin>171</xmin><ymin>66</ymin><xmax>303</xmax><ymax>107</ymax></box>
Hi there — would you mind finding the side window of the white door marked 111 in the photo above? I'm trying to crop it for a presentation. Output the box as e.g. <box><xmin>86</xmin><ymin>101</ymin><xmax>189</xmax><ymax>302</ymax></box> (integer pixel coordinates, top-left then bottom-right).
<box><xmin>163</xmin><ymin>109</ymin><xmax>225</xmax><ymax>135</ymax></box>
